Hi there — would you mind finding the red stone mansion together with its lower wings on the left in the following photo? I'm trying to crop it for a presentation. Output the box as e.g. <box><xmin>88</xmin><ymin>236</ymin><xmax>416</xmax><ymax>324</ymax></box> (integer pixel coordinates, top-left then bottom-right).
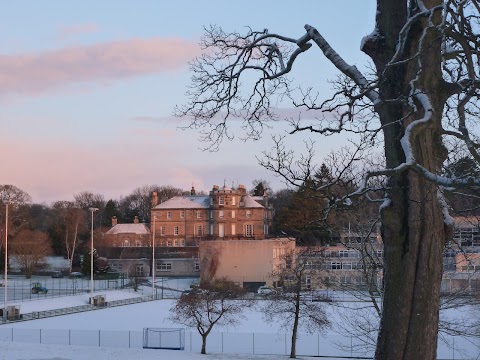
<box><xmin>101</xmin><ymin>185</ymin><xmax>278</xmax><ymax>276</ymax></box>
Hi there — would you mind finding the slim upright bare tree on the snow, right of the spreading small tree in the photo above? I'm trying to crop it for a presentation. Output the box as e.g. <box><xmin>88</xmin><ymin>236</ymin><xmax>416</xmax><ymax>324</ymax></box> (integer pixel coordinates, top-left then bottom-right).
<box><xmin>261</xmin><ymin>248</ymin><xmax>330</xmax><ymax>359</ymax></box>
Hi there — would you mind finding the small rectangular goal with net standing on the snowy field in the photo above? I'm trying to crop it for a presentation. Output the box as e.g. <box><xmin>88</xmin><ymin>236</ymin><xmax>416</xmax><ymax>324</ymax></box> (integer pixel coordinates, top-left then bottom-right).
<box><xmin>143</xmin><ymin>328</ymin><xmax>185</xmax><ymax>350</ymax></box>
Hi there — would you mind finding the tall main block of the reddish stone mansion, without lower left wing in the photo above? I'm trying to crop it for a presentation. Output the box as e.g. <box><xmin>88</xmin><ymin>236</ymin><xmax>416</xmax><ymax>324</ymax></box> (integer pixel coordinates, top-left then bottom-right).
<box><xmin>150</xmin><ymin>185</ymin><xmax>271</xmax><ymax>247</ymax></box>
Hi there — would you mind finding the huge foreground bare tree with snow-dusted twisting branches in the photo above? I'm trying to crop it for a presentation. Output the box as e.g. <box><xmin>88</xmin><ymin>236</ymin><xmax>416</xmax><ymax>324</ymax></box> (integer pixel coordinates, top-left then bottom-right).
<box><xmin>177</xmin><ymin>0</ymin><xmax>480</xmax><ymax>360</ymax></box>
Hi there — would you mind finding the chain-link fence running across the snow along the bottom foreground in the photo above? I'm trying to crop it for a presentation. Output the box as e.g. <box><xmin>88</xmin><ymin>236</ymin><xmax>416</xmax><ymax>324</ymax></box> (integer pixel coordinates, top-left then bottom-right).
<box><xmin>0</xmin><ymin>327</ymin><xmax>480</xmax><ymax>360</ymax></box>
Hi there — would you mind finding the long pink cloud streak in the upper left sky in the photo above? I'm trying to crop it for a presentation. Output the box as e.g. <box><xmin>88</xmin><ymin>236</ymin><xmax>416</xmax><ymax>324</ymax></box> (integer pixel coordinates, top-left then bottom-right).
<box><xmin>0</xmin><ymin>38</ymin><xmax>200</xmax><ymax>96</ymax></box>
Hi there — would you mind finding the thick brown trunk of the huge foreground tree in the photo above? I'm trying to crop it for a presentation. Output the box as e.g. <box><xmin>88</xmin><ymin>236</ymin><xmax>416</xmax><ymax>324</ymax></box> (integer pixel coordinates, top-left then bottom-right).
<box><xmin>364</xmin><ymin>0</ymin><xmax>447</xmax><ymax>360</ymax></box>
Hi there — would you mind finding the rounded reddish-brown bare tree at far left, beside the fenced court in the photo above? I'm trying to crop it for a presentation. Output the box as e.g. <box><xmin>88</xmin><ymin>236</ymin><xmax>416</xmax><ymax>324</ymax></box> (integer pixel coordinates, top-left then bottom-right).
<box><xmin>10</xmin><ymin>229</ymin><xmax>52</xmax><ymax>279</ymax></box>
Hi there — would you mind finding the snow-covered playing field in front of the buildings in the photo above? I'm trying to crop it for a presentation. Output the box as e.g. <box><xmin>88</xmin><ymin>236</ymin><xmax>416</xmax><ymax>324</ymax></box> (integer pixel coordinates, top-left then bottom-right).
<box><xmin>0</xmin><ymin>284</ymin><xmax>480</xmax><ymax>360</ymax></box>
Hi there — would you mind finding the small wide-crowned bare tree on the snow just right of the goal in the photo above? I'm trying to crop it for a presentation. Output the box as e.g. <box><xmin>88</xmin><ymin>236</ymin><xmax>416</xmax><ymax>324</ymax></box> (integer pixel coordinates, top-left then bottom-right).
<box><xmin>170</xmin><ymin>278</ymin><xmax>251</xmax><ymax>354</ymax></box>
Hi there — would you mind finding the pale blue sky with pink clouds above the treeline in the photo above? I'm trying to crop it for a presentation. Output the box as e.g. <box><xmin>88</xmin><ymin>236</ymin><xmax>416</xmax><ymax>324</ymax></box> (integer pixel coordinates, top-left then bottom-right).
<box><xmin>0</xmin><ymin>0</ymin><xmax>375</xmax><ymax>204</ymax></box>
